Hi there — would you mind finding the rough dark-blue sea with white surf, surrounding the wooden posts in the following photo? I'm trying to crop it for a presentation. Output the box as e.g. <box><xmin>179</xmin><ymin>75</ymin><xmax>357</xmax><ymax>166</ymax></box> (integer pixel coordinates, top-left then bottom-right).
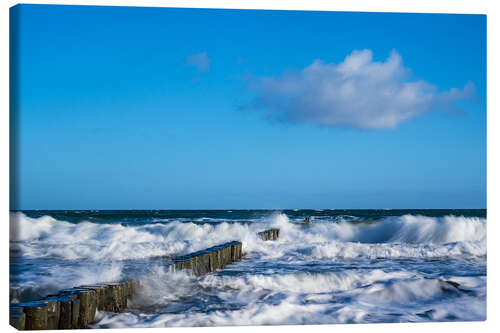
<box><xmin>10</xmin><ymin>209</ymin><xmax>487</xmax><ymax>328</ymax></box>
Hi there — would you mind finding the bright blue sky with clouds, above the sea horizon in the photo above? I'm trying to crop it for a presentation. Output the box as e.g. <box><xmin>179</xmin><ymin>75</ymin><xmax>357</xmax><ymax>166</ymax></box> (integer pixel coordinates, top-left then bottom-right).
<box><xmin>11</xmin><ymin>5</ymin><xmax>486</xmax><ymax>209</ymax></box>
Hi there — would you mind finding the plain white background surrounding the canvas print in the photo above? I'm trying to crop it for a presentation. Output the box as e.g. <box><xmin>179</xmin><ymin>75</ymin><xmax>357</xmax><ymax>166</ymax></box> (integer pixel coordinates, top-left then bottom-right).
<box><xmin>0</xmin><ymin>0</ymin><xmax>500</xmax><ymax>333</ymax></box>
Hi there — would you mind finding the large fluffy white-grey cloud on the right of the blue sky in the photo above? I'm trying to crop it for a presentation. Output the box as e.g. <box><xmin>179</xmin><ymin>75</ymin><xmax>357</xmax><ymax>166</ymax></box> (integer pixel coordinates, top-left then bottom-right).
<box><xmin>249</xmin><ymin>50</ymin><xmax>475</xmax><ymax>129</ymax></box>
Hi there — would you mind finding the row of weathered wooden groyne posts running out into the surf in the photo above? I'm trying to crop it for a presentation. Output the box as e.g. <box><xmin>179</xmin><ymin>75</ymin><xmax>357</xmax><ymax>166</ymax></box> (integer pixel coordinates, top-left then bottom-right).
<box><xmin>10</xmin><ymin>229</ymin><xmax>279</xmax><ymax>330</ymax></box>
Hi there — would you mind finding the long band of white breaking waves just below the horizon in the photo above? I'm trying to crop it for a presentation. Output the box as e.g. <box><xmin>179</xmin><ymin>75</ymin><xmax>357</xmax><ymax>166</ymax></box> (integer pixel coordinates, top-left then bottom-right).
<box><xmin>10</xmin><ymin>213</ymin><xmax>486</xmax><ymax>261</ymax></box>
